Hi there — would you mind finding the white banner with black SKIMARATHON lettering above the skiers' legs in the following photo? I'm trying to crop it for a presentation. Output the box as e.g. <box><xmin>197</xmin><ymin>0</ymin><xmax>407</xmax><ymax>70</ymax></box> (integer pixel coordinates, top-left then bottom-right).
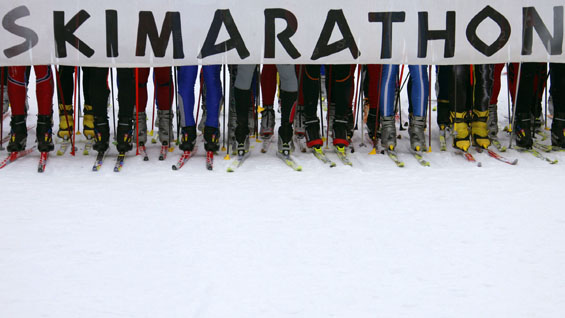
<box><xmin>0</xmin><ymin>0</ymin><xmax>565</xmax><ymax>67</ymax></box>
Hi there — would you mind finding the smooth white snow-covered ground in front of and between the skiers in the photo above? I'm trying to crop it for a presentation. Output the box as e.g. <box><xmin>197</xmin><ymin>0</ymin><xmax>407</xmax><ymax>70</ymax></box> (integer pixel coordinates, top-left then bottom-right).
<box><xmin>0</xmin><ymin>66</ymin><xmax>565</xmax><ymax>318</ymax></box>
